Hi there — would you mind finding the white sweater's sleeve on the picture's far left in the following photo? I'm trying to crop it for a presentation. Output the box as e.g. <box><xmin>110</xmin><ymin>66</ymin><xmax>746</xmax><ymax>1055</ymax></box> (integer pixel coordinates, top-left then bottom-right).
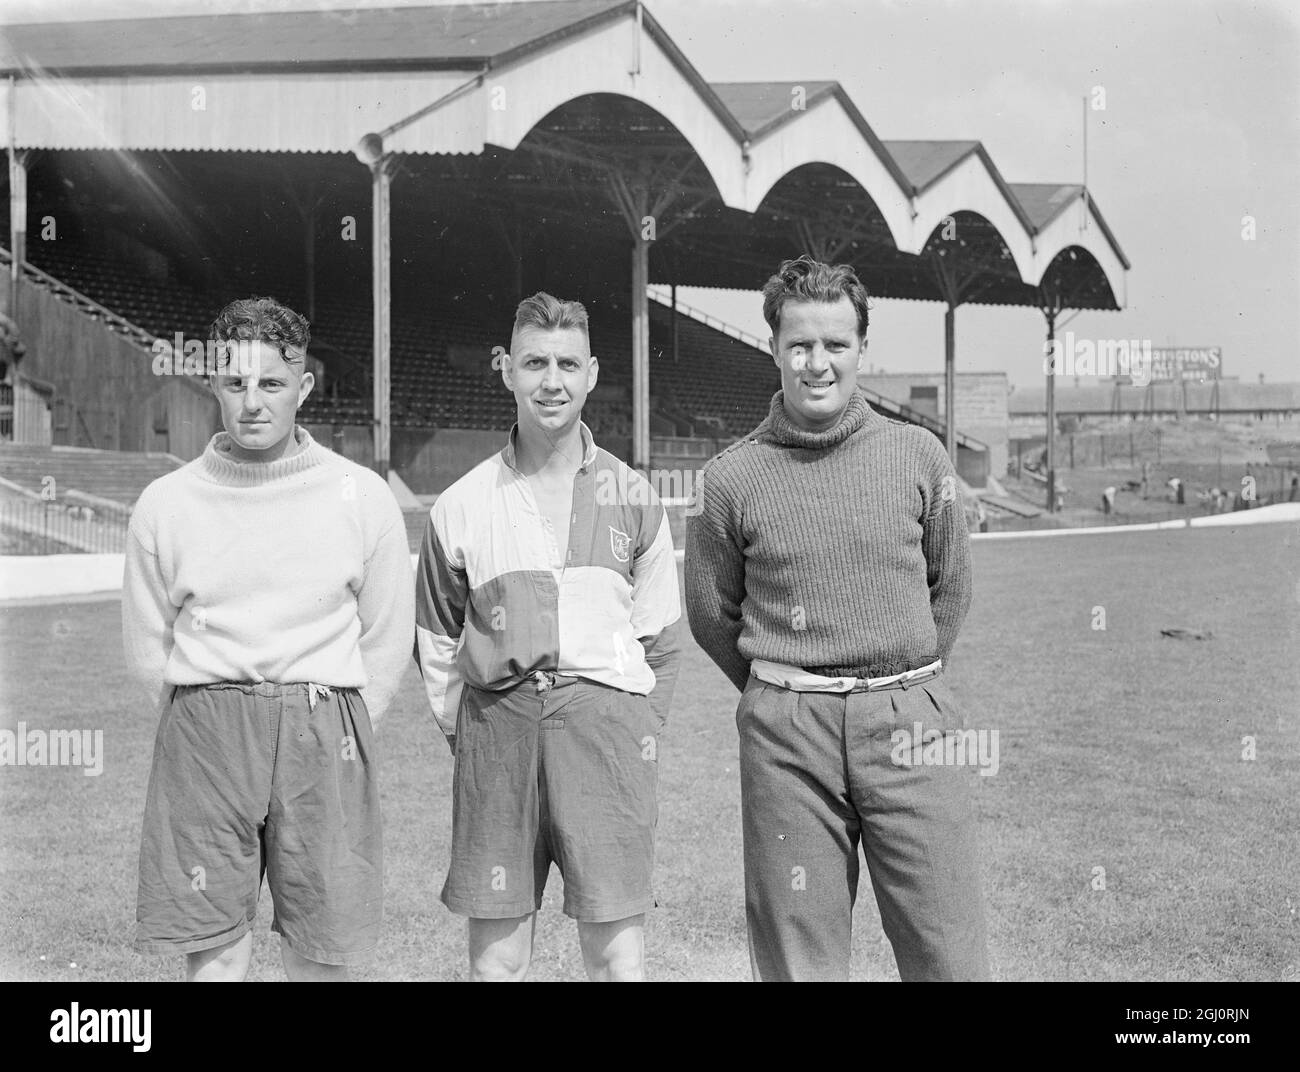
<box><xmin>122</xmin><ymin>517</ymin><xmax>181</xmax><ymax>711</ymax></box>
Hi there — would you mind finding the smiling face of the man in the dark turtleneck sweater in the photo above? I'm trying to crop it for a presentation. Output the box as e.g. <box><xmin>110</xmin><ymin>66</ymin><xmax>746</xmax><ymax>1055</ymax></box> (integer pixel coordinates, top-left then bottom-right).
<box><xmin>771</xmin><ymin>295</ymin><xmax>867</xmax><ymax>431</ymax></box>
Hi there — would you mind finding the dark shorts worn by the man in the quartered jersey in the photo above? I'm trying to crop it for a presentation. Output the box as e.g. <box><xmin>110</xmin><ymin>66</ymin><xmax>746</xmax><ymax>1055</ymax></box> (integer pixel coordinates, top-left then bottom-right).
<box><xmin>442</xmin><ymin>680</ymin><xmax>659</xmax><ymax>923</ymax></box>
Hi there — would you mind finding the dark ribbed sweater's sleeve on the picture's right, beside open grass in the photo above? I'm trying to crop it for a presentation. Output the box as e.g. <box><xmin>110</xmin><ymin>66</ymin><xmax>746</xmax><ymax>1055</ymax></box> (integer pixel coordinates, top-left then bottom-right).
<box><xmin>920</xmin><ymin>444</ymin><xmax>971</xmax><ymax>664</ymax></box>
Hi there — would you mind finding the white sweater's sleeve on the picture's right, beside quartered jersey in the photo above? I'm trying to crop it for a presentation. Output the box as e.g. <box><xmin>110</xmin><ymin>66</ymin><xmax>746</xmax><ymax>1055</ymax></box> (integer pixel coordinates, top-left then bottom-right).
<box><xmin>356</xmin><ymin>485</ymin><xmax>415</xmax><ymax>726</ymax></box>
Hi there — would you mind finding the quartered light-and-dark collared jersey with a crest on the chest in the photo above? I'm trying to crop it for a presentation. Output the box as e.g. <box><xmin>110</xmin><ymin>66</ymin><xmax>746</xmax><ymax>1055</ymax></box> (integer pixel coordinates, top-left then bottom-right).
<box><xmin>416</xmin><ymin>424</ymin><xmax>681</xmax><ymax>737</ymax></box>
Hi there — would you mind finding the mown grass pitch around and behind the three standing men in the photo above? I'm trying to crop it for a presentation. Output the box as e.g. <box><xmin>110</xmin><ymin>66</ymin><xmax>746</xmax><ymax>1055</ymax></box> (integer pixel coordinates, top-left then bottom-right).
<box><xmin>0</xmin><ymin>524</ymin><xmax>1300</xmax><ymax>981</ymax></box>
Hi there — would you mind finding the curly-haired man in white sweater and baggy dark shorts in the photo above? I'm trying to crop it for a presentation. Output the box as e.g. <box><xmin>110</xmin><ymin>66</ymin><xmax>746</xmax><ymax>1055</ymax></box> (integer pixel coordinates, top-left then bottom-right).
<box><xmin>122</xmin><ymin>298</ymin><xmax>415</xmax><ymax>981</ymax></box>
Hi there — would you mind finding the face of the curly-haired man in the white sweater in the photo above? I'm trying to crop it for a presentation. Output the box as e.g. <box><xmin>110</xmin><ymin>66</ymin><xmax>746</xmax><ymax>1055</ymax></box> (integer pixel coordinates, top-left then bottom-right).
<box><xmin>212</xmin><ymin>339</ymin><xmax>316</xmax><ymax>461</ymax></box>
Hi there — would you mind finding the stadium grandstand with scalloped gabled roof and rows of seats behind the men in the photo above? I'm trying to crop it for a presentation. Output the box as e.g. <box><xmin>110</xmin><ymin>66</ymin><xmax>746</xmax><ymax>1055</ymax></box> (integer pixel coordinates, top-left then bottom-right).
<box><xmin>0</xmin><ymin>0</ymin><xmax>1128</xmax><ymax>530</ymax></box>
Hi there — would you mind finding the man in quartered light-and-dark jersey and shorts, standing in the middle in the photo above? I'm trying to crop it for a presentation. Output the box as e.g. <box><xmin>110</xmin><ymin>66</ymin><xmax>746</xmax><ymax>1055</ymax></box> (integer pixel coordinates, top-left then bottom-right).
<box><xmin>416</xmin><ymin>292</ymin><xmax>681</xmax><ymax>981</ymax></box>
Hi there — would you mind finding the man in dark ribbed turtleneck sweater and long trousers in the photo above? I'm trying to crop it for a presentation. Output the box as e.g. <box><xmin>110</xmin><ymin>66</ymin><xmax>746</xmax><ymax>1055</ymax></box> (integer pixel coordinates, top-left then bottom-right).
<box><xmin>685</xmin><ymin>256</ymin><xmax>988</xmax><ymax>980</ymax></box>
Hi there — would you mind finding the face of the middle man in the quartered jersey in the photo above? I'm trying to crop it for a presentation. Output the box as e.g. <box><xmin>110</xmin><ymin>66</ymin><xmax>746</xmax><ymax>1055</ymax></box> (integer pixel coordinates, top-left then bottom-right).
<box><xmin>501</xmin><ymin>327</ymin><xmax>597</xmax><ymax>435</ymax></box>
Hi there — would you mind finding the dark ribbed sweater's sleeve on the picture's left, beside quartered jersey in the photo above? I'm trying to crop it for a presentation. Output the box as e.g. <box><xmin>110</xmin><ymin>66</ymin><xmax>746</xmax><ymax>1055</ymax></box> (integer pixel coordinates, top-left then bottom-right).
<box><xmin>685</xmin><ymin>468</ymin><xmax>749</xmax><ymax>691</ymax></box>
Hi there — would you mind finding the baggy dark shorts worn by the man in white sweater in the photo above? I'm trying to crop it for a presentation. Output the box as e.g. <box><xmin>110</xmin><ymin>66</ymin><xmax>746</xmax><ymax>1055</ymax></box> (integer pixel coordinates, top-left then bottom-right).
<box><xmin>135</xmin><ymin>682</ymin><xmax>384</xmax><ymax>964</ymax></box>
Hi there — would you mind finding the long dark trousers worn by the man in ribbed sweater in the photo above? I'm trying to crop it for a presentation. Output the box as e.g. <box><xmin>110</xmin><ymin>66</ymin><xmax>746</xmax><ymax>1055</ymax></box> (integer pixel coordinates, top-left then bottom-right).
<box><xmin>736</xmin><ymin>677</ymin><xmax>989</xmax><ymax>981</ymax></box>
